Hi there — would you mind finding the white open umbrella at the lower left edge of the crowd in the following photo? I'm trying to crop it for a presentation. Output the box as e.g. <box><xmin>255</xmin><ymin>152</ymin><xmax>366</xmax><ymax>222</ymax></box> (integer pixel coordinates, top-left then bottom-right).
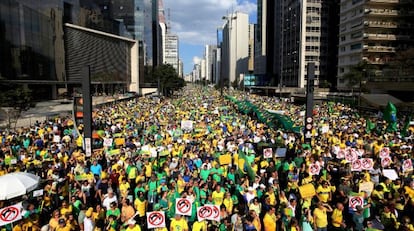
<box><xmin>0</xmin><ymin>172</ymin><xmax>40</xmax><ymax>200</ymax></box>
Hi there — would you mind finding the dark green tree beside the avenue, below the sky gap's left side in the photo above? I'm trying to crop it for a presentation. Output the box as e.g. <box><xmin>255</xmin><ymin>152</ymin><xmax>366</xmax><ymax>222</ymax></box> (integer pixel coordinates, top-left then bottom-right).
<box><xmin>153</xmin><ymin>64</ymin><xmax>185</xmax><ymax>97</ymax></box>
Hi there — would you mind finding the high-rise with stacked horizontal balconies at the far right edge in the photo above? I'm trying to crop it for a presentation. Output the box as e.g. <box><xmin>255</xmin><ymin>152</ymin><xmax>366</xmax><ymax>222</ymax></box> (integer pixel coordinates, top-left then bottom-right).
<box><xmin>337</xmin><ymin>0</ymin><xmax>414</xmax><ymax>89</ymax></box>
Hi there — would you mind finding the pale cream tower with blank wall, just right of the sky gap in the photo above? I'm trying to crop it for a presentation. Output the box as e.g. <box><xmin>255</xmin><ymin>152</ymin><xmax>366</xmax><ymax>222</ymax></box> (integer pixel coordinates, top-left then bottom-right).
<box><xmin>221</xmin><ymin>12</ymin><xmax>249</xmax><ymax>86</ymax></box>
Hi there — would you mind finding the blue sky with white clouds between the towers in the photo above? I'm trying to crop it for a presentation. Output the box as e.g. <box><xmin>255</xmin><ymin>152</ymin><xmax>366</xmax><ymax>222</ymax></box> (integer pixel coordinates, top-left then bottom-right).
<box><xmin>164</xmin><ymin>0</ymin><xmax>257</xmax><ymax>74</ymax></box>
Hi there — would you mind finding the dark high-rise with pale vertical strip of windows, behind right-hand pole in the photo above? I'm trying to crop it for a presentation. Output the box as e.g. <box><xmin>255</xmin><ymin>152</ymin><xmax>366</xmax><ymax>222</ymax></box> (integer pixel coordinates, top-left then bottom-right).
<box><xmin>277</xmin><ymin>0</ymin><xmax>338</xmax><ymax>88</ymax></box>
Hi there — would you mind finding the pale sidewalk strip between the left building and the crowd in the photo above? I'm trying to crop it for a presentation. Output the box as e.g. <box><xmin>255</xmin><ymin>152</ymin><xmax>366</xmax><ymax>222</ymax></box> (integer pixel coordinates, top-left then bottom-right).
<box><xmin>0</xmin><ymin>95</ymin><xmax>133</xmax><ymax>128</ymax></box>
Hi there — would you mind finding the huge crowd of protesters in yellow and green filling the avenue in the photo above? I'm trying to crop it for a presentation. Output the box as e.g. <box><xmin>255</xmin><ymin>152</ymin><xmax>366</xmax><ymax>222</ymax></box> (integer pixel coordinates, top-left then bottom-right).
<box><xmin>0</xmin><ymin>87</ymin><xmax>414</xmax><ymax>231</ymax></box>
